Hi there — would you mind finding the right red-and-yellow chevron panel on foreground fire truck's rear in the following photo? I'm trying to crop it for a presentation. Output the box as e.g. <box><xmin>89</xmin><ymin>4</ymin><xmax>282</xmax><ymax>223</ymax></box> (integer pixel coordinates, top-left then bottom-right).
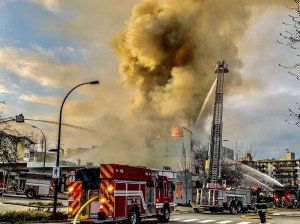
<box><xmin>99</xmin><ymin>180</ymin><xmax>114</xmax><ymax>217</ymax></box>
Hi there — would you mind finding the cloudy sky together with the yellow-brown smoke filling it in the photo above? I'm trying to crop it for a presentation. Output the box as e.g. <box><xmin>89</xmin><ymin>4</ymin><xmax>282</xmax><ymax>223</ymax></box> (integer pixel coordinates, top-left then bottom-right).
<box><xmin>0</xmin><ymin>0</ymin><xmax>300</xmax><ymax>164</ymax></box>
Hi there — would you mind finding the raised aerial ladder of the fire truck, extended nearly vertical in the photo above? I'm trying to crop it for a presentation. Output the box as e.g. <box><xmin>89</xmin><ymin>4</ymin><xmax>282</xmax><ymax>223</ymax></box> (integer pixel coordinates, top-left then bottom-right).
<box><xmin>208</xmin><ymin>60</ymin><xmax>228</xmax><ymax>183</ymax></box>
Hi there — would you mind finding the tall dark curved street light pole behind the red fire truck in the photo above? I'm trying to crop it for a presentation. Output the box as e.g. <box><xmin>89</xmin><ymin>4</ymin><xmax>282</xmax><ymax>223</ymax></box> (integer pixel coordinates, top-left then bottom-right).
<box><xmin>53</xmin><ymin>80</ymin><xmax>99</xmax><ymax>213</ymax></box>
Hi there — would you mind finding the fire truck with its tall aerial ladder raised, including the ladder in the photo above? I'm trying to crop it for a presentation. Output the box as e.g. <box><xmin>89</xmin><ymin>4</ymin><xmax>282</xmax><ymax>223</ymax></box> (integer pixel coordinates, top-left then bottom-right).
<box><xmin>193</xmin><ymin>60</ymin><xmax>254</xmax><ymax>214</ymax></box>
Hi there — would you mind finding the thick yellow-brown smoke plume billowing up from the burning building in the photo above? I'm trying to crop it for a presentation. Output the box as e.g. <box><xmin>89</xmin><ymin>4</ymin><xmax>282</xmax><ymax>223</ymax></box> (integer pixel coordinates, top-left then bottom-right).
<box><xmin>71</xmin><ymin>0</ymin><xmax>280</xmax><ymax>168</ymax></box>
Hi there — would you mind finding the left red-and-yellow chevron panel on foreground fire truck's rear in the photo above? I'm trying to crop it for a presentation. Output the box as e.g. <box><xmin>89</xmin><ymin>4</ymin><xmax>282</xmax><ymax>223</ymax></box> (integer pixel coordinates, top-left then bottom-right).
<box><xmin>68</xmin><ymin>182</ymin><xmax>82</xmax><ymax>217</ymax></box>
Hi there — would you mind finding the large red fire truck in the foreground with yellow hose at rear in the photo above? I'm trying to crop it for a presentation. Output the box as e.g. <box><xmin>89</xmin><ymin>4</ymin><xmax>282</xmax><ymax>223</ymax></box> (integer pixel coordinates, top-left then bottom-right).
<box><xmin>68</xmin><ymin>164</ymin><xmax>175</xmax><ymax>223</ymax></box>
